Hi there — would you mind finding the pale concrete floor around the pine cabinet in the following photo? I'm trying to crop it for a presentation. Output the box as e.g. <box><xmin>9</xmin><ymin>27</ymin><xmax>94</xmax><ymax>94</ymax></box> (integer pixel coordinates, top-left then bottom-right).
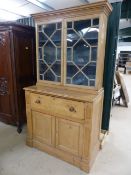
<box><xmin>0</xmin><ymin>75</ymin><xmax>131</xmax><ymax>175</ymax></box>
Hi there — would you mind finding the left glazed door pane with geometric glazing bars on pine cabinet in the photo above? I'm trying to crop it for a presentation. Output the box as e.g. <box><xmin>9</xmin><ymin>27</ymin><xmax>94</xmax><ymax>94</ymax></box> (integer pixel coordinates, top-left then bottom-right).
<box><xmin>37</xmin><ymin>22</ymin><xmax>62</xmax><ymax>82</ymax></box>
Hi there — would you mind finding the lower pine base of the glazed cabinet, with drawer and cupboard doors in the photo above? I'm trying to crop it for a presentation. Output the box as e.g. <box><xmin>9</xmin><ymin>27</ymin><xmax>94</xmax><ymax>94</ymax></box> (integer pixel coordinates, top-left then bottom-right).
<box><xmin>25</xmin><ymin>86</ymin><xmax>103</xmax><ymax>172</ymax></box>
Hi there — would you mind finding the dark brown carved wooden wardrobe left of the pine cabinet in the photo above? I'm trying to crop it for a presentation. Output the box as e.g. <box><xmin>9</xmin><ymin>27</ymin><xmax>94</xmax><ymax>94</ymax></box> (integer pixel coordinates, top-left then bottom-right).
<box><xmin>0</xmin><ymin>23</ymin><xmax>36</xmax><ymax>132</ymax></box>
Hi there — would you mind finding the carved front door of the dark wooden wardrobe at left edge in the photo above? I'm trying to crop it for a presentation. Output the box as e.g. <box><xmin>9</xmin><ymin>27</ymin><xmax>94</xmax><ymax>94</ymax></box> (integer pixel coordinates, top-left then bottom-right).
<box><xmin>0</xmin><ymin>31</ymin><xmax>15</xmax><ymax>123</ymax></box>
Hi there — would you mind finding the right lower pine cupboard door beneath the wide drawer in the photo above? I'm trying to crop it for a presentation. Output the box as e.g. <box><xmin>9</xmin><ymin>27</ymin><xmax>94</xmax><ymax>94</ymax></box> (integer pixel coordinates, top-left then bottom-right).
<box><xmin>56</xmin><ymin>119</ymin><xmax>83</xmax><ymax>156</ymax></box>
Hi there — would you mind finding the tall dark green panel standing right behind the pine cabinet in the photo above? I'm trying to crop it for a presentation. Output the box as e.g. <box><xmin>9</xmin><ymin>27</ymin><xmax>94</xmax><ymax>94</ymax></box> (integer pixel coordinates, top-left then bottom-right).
<box><xmin>102</xmin><ymin>2</ymin><xmax>121</xmax><ymax>130</ymax></box>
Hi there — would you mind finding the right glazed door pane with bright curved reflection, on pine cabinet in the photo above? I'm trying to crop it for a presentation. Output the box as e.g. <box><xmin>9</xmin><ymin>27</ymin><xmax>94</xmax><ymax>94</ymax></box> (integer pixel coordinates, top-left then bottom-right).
<box><xmin>65</xmin><ymin>18</ymin><xmax>99</xmax><ymax>87</ymax></box>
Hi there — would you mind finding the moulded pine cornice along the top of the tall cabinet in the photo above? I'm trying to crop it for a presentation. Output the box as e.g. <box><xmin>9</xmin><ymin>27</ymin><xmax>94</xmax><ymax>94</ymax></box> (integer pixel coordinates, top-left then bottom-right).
<box><xmin>32</xmin><ymin>0</ymin><xmax>112</xmax><ymax>21</ymax></box>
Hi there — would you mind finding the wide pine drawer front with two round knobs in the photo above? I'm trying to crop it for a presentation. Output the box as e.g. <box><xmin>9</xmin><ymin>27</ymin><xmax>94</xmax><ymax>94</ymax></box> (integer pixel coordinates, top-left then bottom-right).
<box><xmin>31</xmin><ymin>93</ymin><xmax>84</xmax><ymax>120</ymax></box>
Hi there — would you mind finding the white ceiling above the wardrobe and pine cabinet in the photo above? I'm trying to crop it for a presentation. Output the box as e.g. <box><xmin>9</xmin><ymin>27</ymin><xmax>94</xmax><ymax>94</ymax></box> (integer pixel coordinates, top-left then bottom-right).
<box><xmin>0</xmin><ymin>0</ymin><xmax>121</xmax><ymax>21</ymax></box>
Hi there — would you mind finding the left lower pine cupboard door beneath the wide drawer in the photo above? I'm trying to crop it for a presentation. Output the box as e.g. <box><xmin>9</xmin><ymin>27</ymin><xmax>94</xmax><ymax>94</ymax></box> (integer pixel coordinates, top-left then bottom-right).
<box><xmin>32</xmin><ymin>111</ymin><xmax>55</xmax><ymax>145</ymax></box>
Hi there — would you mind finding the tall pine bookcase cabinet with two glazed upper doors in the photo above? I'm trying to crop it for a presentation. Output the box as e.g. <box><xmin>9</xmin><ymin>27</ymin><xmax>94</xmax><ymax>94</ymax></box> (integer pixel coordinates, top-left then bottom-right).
<box><xmin>25</xmin><ymin>1</ymin><xmax>112</xmax><ymax>172</ymax></box>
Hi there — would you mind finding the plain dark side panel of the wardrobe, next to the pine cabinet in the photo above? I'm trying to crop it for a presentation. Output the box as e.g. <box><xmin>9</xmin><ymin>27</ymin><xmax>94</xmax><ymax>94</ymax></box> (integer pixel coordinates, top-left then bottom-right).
<box><xmin>13</xmin><ymin>31</ymin><xmax>36</xmax><ymax>123</ymax></box>
